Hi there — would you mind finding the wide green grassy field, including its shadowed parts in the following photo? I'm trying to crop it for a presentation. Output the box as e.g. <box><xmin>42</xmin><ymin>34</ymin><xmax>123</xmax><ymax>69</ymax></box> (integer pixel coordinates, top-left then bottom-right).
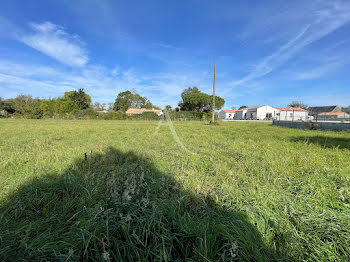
<box><xmin>0</xmin><ymin>120</ymin><xmax>350</xmax><ymax>261</ymax></box>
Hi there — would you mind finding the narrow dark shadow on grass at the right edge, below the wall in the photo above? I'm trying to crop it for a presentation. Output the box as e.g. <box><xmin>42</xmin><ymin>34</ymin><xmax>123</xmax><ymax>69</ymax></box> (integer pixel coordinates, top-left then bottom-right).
<box><xmin>291</xmin><ymin>136</ymin><xmax>350</xmax><ymax>149</ymax></box>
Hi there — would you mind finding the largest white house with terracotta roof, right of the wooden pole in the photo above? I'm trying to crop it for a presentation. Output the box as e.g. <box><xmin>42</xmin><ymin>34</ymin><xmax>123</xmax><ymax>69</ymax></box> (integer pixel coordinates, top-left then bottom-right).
<box><xmin>235</xmin><ymin>105</ymin><xmax>278</xmax><ymax>120</ymax></box>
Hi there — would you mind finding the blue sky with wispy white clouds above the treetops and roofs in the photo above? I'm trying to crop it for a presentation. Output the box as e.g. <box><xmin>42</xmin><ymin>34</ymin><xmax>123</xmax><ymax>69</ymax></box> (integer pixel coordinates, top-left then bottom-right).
<box><xmin>0</xmin><ymin>0</ymin><xmax>350</xmax><ymax>108</ymax></box>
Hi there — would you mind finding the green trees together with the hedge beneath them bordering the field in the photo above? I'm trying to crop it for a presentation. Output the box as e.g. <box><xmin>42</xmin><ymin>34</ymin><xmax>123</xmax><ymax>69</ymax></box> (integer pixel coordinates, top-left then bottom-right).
<box><xmin>0</xmin><ymin>87</ymin><xmax>225</xmax><ymax>121</ymax></box>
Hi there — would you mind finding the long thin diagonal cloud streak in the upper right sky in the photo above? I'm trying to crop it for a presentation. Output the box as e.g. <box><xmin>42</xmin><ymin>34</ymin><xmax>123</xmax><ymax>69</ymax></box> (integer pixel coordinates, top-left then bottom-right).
<box><xmin>232</xmin><ymin>2</ymin><xmax>350</xmax><ymax>86</ymax></box>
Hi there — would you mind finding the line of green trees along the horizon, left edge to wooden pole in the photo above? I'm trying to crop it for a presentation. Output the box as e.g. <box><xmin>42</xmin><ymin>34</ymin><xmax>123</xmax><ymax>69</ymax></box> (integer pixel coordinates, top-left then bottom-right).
<box><xmin>0</xmin><ymin>87</ymin><xmax>225</xmax><ymax>119</ymax></box>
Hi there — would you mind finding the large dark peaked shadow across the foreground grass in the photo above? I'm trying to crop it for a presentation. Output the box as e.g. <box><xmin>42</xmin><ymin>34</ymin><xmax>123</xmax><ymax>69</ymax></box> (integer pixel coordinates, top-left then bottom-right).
<box><xmin>0</xmin><ymin>148</ymin><xmax>286</xmax><ymax>261</ymax></box>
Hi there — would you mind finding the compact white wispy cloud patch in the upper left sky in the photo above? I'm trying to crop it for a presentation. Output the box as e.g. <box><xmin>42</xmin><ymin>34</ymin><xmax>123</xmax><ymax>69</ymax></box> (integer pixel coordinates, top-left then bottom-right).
<box><xmin>18</xmin><ymin>22</ymin><xmax>88</xmax><ymax>66</ymax></box>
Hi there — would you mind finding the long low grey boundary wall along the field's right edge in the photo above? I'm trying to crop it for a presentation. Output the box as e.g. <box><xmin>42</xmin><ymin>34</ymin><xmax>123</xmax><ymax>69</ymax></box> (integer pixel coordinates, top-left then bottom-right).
<box><xmin>272</xmin><ymin>120</ymin><xmax>350</xmax><ymax>131</ymax></box>
